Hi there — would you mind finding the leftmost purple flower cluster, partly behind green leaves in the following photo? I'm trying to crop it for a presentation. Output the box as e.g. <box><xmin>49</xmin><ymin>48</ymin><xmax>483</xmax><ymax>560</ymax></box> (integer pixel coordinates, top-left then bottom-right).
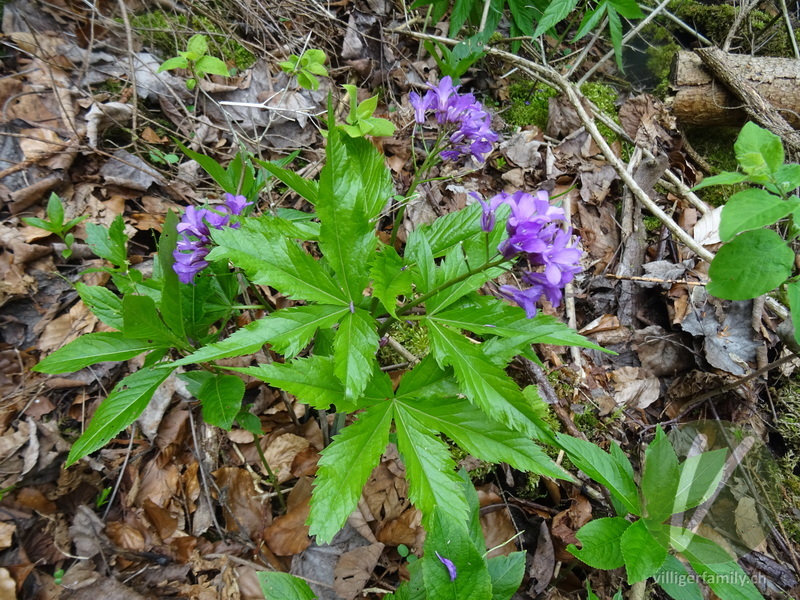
<box><xmin>172</xmin><ymin>194</ymin><xmax>252</xmax><ymax>283</ymax></box>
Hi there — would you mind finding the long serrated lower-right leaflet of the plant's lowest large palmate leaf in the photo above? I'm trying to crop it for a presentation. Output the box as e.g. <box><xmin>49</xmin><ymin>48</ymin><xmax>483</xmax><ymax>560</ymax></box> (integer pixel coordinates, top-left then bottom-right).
<box><xmin>398</xmin><ymin>398</ymin><xmax>572</xmax><ymax>480</ymax></box>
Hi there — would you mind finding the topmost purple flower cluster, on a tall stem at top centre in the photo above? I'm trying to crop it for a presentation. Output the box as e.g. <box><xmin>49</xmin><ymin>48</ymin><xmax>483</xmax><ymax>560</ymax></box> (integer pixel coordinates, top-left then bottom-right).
<box><xmin>408</xmin><ymin>75</ymin><xmax>497</xmax><ymax>163</ymax></box>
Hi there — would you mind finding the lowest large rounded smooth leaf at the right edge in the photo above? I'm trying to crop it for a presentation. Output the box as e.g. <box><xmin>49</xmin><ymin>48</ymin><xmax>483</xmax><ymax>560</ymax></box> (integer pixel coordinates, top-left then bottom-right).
<box><xmin>706</xmin><ymin>229</ymin><xmax>794</xmax><ymax>300</ymax></box>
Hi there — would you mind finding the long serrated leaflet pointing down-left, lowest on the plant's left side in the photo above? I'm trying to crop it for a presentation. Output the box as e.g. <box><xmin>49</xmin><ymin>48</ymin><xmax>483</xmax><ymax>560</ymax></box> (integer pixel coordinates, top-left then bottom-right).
<box><xmin>65</xmin><ymin>365</ymin><xmax>172</xmax><ymax>467</ymax></box>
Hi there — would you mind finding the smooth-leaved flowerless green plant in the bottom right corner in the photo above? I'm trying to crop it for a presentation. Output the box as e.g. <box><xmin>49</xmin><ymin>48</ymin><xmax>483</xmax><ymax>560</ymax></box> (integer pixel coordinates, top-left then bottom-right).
<box><xmin>558</xmin><ymin>427</ymin><xmax>761</xmax><ymax>600</ymax></box>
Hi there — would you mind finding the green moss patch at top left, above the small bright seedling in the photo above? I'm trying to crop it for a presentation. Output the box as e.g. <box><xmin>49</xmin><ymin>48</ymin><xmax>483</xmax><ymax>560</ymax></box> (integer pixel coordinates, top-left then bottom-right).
<box><xmin>131</xmin><ymin>10</ymin><xmax>256</xmax><ymax>70</ymax></box>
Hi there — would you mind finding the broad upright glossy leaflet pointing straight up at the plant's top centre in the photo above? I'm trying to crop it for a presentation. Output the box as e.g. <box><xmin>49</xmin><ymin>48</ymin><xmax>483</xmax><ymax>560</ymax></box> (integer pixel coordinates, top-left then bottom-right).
<box><xmin>317</xmin><ymin>127</ymin><xmax>392</xmax><ymax>302</ymax></box>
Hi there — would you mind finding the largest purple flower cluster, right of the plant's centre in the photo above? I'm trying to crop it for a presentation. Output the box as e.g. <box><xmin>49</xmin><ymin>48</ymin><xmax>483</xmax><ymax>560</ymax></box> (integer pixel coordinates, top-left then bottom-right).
<box><xmin>479</xmin><ymin>190</ymin><xmax>582</xmax><ymax>318</ymax></box>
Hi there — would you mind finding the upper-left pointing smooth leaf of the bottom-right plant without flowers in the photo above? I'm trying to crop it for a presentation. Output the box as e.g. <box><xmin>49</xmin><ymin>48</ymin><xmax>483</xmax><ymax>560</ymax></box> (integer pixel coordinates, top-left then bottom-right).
<box><xmin>556</xmin><ymin>433</ymin><xmax>642</xmax><ymax>512</ymax></box>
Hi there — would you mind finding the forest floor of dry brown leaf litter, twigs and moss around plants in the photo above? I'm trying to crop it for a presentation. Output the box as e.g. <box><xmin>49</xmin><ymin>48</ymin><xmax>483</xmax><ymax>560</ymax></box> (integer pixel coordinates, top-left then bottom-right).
<box><xmin>0</xmin><ymin>0</ymin><xmax>800</xmax><ymax>600</ymax></box>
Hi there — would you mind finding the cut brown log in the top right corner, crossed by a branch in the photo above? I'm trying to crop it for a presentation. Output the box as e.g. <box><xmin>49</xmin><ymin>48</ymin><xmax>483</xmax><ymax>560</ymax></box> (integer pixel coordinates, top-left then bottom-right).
<box><xmin>671</xmin><ymin>49</ymin><xmax>800</xmax><ymax>128</ymax></box>
